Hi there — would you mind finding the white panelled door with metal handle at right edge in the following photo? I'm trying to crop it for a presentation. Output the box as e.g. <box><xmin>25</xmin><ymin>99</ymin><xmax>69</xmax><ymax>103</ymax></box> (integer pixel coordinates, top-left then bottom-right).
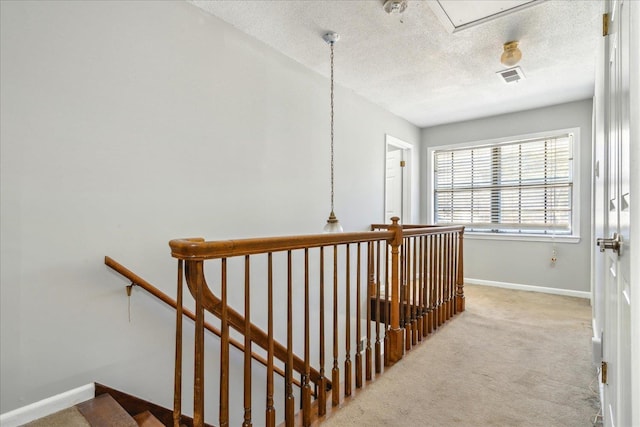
<box><xmin>596</xmin><ymin>0</ymin><xmax>632</xmax><ymax>427</ymax></box>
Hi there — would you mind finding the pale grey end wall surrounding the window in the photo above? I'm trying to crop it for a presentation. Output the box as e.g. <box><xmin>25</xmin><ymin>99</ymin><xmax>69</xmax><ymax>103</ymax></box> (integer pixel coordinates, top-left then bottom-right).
<box><xmin>421</xmin><ymin>100</ymin><xmax>592</xmax><ymax>296</ymax></box>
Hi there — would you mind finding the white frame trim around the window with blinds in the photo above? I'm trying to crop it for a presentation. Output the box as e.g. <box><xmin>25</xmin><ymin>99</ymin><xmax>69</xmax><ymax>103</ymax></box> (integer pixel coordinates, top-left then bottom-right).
<box><xmin>426</xmin><ymin>127</ymin><xmax>581</xmax><ymax>243</ymax></box>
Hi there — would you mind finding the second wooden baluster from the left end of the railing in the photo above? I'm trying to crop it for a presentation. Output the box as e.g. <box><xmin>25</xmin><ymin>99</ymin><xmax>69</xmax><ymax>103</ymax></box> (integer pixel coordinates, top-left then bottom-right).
<box><xmin>193</xmin><ymin>261</ymin><xmax>204</xmax><ymax>427</ymax></box>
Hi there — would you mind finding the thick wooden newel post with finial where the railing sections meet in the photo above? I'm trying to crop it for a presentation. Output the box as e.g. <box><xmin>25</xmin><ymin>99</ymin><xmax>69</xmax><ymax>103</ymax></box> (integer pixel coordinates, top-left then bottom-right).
<box><xmin>388</xmin><ymin>216</ymin><xmax>404</xmax><ymax>365</ymax></box>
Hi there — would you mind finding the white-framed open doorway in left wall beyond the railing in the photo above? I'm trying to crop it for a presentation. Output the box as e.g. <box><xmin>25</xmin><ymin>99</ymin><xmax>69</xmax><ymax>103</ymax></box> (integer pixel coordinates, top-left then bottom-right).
<box><xmin>384</xmin><ymin>135</ymin><xmax>413</xmax><ymax>224</ymax></box>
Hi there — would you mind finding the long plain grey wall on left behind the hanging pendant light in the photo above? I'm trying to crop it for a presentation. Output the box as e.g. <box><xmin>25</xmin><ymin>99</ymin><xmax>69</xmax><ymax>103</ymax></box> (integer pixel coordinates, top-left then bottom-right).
<box><xmin>0</xmin><ymin>1</ymin><xmax>420</xmax><ymax>418</ymax></box>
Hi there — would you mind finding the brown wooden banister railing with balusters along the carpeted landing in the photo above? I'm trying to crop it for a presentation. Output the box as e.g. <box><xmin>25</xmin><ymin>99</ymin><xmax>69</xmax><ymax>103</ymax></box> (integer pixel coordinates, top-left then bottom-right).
<box><xmin>169</xmin><ymin>218</ymin><xmax>464</xmax><ymax>426</ymax></box>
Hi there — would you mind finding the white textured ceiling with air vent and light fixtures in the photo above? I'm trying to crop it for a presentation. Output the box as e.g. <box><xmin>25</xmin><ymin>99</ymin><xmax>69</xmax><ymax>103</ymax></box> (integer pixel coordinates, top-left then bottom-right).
<box><xmin>191</xmin><ymin>0</ymin><xmax>602</xmax><ymax>127</ymax></box>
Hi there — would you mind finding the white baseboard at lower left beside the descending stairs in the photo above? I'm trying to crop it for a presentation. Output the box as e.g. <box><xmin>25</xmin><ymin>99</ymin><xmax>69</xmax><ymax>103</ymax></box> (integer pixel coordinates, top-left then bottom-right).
<box><xmin>0</xmin><ymin>383</ymin><xmax>96</xmax><ymax>427</ymax></box>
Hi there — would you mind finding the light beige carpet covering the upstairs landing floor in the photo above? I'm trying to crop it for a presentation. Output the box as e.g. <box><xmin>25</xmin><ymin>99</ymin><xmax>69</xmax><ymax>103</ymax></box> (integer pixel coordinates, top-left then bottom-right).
<box><xmin>323</xmin><ymin>286</ymin><xmax>600</xmax><ymax>427</ymax></box>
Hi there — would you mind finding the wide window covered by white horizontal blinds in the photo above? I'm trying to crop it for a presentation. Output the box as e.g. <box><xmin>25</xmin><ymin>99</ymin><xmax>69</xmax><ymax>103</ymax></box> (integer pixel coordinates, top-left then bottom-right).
<box><xmin>433</xmin><ymin>133</ymin><xmax>574</xmax><ymax>235</ymax></box>
